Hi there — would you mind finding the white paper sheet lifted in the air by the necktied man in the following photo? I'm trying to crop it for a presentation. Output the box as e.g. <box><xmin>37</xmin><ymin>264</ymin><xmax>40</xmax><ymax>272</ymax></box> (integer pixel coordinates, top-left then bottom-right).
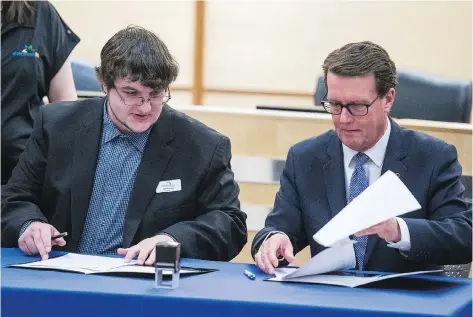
<box><xmin>313</xmin><ymin>171</ymin><xmax>421</xmax><ymax>247</ymax></box>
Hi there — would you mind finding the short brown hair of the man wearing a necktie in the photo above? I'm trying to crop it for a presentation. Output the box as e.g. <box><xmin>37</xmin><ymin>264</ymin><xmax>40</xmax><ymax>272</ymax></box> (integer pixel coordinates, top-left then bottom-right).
<box><xmin>322</xmin><ymin>41</ymin><xmax>397</xmax><ymax>96</ymax></box>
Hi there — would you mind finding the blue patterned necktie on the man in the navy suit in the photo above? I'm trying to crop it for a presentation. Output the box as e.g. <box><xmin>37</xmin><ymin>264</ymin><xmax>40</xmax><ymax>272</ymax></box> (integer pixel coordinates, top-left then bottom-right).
<box><xmin>348</xmin><ymin>152</ymin><xmax>370</xmax><ymax>270</ymax></box>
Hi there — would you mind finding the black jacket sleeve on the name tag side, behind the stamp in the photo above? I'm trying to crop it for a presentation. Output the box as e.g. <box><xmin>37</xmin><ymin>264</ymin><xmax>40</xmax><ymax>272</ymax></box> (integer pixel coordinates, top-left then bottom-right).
<box><xmin>163</xmin><ymin>137</ymin><xmax>248</xmax><ymax>261</ymax></box>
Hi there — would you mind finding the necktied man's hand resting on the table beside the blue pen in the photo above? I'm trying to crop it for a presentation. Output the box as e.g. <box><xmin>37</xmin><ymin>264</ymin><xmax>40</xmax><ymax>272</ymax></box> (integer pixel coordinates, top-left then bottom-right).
<box><xmin>255</xmin><ymin>233</ymin><xmax>296</xmax><ymax>274</ymax></box>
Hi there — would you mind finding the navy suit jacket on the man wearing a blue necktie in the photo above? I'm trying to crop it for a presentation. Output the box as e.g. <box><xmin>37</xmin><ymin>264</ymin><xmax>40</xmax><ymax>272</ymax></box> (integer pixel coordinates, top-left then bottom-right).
<box><xmin>252</xmin><ymin>121</ymin><xmax>472</xmax><ymax>272</ymax></box>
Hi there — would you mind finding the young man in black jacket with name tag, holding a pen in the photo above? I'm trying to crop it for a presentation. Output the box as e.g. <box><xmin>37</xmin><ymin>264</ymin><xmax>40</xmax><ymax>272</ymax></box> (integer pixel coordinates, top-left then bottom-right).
<box><xmin>2</xmin><ymin>27</ymin><xmax>247</xmax><ymax>265</ymax></box>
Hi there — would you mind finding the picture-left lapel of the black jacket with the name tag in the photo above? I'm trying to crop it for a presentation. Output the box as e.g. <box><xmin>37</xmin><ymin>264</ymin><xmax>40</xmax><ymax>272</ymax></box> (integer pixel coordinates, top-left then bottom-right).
<box><xmin>69</xmin><ymin>98</ymin><xmax>104</xmax><ymax>250</ymax></box>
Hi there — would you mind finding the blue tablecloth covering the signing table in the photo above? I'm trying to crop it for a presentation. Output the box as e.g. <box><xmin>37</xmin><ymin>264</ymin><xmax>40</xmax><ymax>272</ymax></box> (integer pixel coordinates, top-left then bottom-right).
<box><xmin>1</xmin><ymin>249</ymin><xmax>472</xmax><ymax>317</ymax></box>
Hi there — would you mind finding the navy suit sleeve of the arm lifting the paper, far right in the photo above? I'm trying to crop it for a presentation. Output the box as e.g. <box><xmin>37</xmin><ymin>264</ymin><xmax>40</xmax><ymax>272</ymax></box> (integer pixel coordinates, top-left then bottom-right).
<box><xmin>404</xmin><ymin>145</ymin><xmax>472</xmax><ymax>265</ymax></box>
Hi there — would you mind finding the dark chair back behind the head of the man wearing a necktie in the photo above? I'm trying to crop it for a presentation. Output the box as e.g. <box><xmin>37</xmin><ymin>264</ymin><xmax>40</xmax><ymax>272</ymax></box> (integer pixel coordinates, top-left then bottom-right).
<box><xmin>314</xmin><ymin>71</ymin><xmax>472</xmax><ymax>123</ymax></box>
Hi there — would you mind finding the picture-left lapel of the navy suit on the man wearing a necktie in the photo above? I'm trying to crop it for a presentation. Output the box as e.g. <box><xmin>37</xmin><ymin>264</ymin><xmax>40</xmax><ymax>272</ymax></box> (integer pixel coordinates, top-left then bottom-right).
<box><xmin>323</xmin><ymin>134</ymin><xmax>346</xmax><ymax>218</ymax></box>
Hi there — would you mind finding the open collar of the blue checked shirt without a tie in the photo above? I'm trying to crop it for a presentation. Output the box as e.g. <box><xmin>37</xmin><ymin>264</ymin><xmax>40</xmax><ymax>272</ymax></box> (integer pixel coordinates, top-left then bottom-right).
<box><xmin>101</xmin><ymin>98</ymin><xmax>151</xmax><ymax>153</ymax></box>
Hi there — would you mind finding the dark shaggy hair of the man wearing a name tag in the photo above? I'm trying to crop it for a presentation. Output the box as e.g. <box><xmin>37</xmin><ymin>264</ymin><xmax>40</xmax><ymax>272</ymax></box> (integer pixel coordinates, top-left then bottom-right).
<box><xmin>95</xmin><ymin>26</ymin><xmax>179</xmax><ymax>90</ymax></box>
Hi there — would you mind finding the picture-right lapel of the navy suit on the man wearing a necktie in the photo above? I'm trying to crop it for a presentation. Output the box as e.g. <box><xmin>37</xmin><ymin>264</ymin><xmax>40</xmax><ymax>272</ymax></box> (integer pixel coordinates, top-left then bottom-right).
<box><xmin>364</xmin><ymin>118</ymin><xmax>407</xmax><ymax>267</ymax></box>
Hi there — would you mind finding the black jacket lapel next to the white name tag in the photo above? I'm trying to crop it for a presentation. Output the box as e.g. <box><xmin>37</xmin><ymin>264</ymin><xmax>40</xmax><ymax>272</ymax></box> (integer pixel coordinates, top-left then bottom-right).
<box><xmin>123</xmin><ymin>106</ymin><xmax>174</xmax><ymax>248</ymax></box>
